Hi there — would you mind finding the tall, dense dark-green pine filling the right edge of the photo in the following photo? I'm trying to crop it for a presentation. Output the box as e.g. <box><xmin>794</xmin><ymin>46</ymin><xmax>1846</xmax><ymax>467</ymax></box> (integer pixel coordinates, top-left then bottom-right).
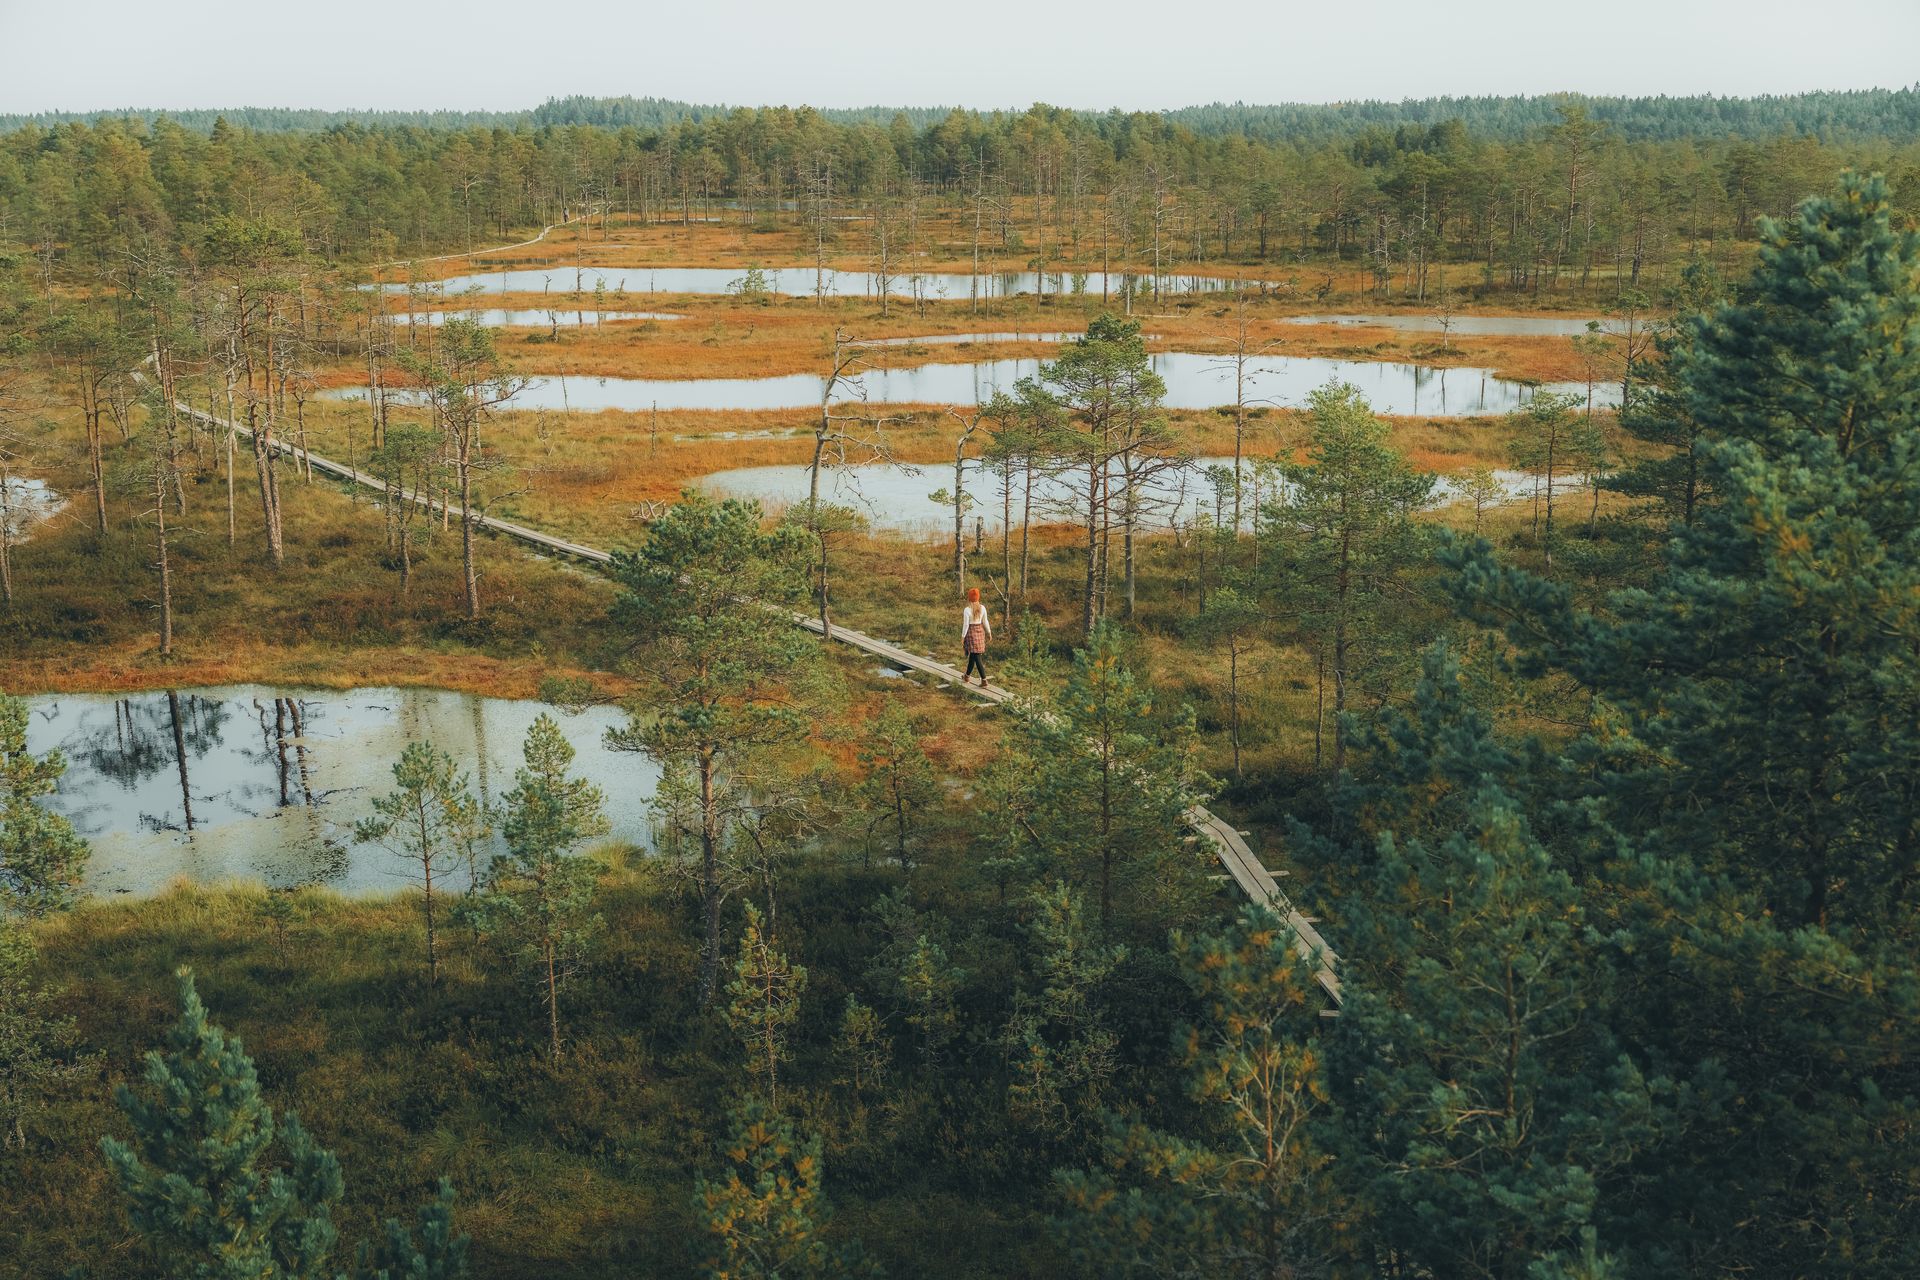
<box><xmin>1459</xmin><ymin>175</ymin><xmax>1920</xmax><ymax>1276</ymax></box>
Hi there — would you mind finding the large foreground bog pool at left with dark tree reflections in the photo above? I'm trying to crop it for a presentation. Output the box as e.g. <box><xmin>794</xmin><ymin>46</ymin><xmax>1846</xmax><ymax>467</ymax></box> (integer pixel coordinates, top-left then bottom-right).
<box><xmin>27</xmin><ymin>685</ymin><xmax>659</xmax><ymax>894</ymax></box>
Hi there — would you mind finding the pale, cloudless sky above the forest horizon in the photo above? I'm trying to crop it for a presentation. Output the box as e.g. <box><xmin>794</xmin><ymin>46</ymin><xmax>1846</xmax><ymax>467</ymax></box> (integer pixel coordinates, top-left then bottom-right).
<box><xmin>0</xmin><ymin>0</ymin><xmax>1920</xmax><ymax>111</ymax></box>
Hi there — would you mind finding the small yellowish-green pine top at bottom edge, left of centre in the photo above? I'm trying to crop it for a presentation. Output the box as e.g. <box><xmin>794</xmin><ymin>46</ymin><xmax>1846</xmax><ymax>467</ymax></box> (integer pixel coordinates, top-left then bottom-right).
<box><xmin>693</xmin><ymin>1102</ymin><xmax>872</xmax><ymax>1280</ymax></box>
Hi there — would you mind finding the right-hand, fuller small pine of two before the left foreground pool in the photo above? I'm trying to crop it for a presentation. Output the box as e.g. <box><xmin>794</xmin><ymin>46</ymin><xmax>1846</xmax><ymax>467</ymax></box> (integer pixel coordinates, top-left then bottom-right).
<box><xmin>480</xmin><ymin>714</ymin><xmax>607</xmax><ymax>1059</ymax></box>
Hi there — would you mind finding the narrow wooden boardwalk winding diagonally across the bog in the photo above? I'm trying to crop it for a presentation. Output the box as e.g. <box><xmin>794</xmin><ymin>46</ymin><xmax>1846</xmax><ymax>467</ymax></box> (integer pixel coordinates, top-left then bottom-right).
<box><xmin>175</xmin><ymin>403</ymin><xmax>1340</xmax><ymax>1006</ymax></box>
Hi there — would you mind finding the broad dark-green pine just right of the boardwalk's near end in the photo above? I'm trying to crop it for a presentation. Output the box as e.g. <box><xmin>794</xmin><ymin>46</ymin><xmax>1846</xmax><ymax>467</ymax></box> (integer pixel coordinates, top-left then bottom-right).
<box><xmin>1300</xmin><ymin>651</ymin><xmax>1657</xmax><ymax>1280</ymax></box>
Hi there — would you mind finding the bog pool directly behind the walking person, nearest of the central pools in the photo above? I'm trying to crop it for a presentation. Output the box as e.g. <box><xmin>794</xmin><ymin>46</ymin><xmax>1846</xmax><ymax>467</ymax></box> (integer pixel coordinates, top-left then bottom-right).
<box><xmin>699</xmin><ymin>457</ymin><xmax>1584</xmax><ymax>539</ymax></box>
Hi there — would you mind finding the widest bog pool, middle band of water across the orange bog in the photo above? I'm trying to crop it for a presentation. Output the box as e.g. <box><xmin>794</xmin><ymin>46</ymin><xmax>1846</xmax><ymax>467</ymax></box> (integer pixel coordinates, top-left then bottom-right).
<box><xmin>321</xmin><ymin>351</ymin><xmax>1619</xmax><ymax>416</ymax></box>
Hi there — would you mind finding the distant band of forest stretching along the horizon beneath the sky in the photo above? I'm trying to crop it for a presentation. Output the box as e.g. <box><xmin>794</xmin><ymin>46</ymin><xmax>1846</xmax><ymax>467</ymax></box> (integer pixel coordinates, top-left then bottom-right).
<box><xmin>0</xmin><ymin>90</ymin><xmax>1920</xmax><ymax>297</ymax></box>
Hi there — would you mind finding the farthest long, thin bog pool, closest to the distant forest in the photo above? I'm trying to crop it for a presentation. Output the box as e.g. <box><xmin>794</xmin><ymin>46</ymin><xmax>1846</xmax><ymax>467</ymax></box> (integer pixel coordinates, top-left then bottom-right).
<box><xmin>374</xmin><ymin>265</ymin><xmax>1260</xmax><ymax>301</ymax></box>
